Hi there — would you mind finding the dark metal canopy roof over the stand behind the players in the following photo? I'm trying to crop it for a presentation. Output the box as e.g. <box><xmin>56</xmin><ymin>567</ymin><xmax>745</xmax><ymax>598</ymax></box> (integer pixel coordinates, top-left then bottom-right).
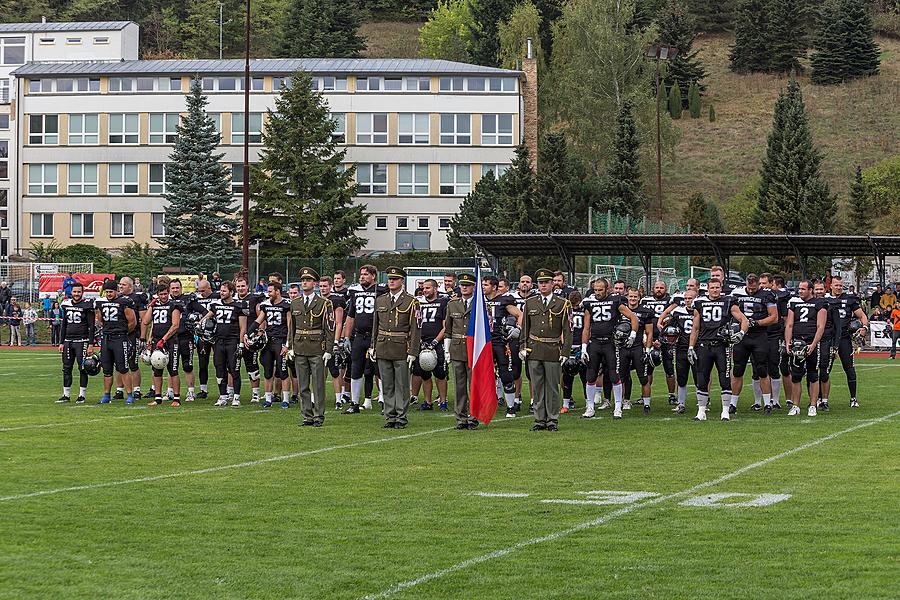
<box><xmin>467</xmin><ymin>233</ymin><xmax>900</xmax><ymax>284</ymax></box>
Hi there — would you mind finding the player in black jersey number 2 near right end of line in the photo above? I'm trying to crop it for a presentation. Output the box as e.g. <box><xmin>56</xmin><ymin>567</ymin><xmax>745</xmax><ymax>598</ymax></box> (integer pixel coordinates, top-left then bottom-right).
<box><xmin>784</xmin><ymin>280</ymin><xmax>828</xmax><ymax>417</ymax></box>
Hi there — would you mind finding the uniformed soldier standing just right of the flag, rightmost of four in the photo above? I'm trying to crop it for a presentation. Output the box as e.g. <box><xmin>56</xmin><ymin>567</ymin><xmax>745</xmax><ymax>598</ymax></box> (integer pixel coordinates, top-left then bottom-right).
<box><xmin>519</xmin><ymin>269</ymin><xmax>572</xmax><ymax>431</ymax></box>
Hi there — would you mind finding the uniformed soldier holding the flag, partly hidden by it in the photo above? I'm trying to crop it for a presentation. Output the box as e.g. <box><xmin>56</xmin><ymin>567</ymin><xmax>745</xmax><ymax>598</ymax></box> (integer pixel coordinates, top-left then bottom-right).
<box><xmin>444</xmin><ymin>273</ymin><xmax>478</xmax><ymax>429</ymax></box>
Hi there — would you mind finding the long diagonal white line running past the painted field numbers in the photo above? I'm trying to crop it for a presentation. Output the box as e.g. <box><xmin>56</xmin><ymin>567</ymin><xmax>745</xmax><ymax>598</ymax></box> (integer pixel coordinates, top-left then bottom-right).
<box><xmin>364</xmin><ymin>411</ymin><xmax>900</xmax><ymax>600</ymax></box>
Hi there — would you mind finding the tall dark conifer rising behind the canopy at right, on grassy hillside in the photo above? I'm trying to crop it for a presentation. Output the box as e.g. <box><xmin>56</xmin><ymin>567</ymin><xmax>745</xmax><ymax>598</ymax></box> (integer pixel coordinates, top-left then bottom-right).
<box><xmin>758</xmin><ymin>77</ymin><xmax>837</xmax><ymax>234</ymax></box>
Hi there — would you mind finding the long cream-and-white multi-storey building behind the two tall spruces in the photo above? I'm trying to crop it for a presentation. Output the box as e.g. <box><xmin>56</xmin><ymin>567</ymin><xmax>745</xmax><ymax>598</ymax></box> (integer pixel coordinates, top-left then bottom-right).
<box><xmin>9</xmin><ymin>52</ymin><xmax>523</xmax><ymax>254</ymax></box>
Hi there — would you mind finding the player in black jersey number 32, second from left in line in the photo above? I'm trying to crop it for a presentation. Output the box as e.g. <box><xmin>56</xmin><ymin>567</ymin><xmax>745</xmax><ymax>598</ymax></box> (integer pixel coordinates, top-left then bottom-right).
<box><xmin>94</xmin><ymin>279</ymin><xmax>137</xmax><ymax>404</ymax></box>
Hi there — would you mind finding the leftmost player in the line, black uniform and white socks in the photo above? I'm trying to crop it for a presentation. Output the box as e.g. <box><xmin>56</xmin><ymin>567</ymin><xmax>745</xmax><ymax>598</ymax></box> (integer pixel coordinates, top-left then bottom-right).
<box><xmin>56</xmin><ymin>283</ymin><xmax>95</xmax><ymax>404</ymax></box>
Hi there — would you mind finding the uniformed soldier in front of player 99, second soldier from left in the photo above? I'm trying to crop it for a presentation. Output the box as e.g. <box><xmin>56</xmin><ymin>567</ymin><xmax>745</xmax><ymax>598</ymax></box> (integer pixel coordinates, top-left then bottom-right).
<box><xmin>369</xmin><ymin>267</ymin><xmax>422</xmax><ymax>429</ymax></box>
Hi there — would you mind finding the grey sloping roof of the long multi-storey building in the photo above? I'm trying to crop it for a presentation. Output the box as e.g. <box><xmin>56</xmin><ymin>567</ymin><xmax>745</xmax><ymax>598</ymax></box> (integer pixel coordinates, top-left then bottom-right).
<box><xmin>13</xmin><ymin>58</ymin><xmax>522</xmax><ymax>77</ymax></box>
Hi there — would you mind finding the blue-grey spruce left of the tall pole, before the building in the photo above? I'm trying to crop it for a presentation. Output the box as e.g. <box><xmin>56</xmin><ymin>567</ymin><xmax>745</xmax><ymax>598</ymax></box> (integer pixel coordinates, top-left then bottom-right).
<box><xmin>160</xmin><ymin>79</ymin><xmax>240</xmax><ymax>268</ymax></box>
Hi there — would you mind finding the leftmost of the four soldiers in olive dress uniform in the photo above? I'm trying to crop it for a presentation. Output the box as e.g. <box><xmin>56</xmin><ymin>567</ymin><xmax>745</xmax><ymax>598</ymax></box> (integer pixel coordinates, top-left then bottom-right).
<box><xmin>291</xmin><ymin>267</ymin><xmax>337</xmax><ymax>427</ymax></box>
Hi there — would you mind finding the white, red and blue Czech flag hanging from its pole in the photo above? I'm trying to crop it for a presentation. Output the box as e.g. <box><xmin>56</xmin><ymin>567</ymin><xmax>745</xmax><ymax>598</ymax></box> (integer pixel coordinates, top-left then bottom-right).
<box><xmin>466</xmin><ymin>263</ymin><xmax>497</xmax><ymax>423</ymax></box>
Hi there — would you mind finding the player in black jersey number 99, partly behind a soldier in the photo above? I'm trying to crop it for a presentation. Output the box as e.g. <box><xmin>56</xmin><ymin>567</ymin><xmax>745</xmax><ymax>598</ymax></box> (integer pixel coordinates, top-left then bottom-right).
<box><xmin>344</xmin><ymin>265</ymin><xmax>387</xmax><ymax>414</ymax></box>
